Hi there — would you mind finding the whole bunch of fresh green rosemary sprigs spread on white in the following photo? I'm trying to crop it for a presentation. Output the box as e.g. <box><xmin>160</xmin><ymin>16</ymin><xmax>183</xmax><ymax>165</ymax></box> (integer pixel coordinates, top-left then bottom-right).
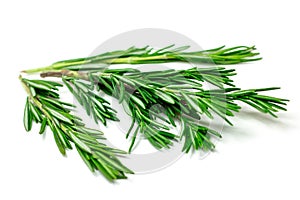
<box><xmin>20</xmin><ymin>45</ymin><xmax>288</xmax><ymax>180</ymax></box>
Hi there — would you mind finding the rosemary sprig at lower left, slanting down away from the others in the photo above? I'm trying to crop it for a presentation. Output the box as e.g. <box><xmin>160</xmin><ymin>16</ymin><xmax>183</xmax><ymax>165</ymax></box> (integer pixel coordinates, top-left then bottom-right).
<box><xmin>20</xmin><ymin>77</ymin><xmax>133</xmax><ymax>181</ymax></box>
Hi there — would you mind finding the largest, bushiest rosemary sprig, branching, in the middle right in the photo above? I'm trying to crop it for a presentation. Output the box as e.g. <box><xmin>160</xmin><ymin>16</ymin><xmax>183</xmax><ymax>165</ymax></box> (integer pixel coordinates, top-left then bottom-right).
<box><xmin>38</xmin><ymin>67</ymin><xmax>288</xmax><ymax>152</ymax></box>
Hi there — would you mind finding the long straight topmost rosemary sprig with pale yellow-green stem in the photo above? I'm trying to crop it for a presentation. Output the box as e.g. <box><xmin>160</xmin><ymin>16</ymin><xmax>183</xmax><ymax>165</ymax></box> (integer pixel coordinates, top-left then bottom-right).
<box><xmin>24</xmin><ymin>44</ymin><xmax>261</xmax><ymax>73</ymax></box>
